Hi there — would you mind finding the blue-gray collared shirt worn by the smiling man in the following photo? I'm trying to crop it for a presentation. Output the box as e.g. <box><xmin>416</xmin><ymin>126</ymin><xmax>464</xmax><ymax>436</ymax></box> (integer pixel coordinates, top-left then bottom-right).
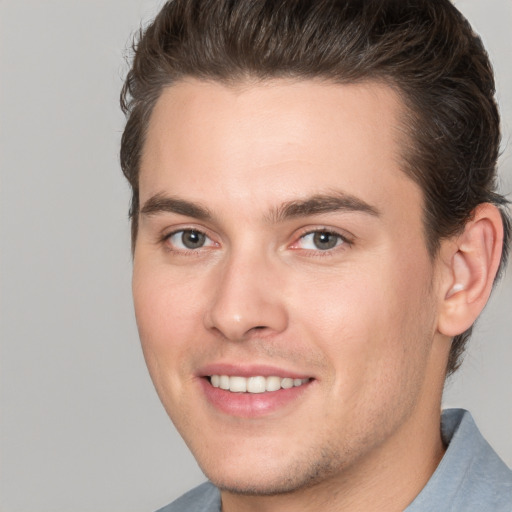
<box><xmin>158</xmin><ymin>409</ymin><xmax>512</xmax><ymax>512</ymax></box>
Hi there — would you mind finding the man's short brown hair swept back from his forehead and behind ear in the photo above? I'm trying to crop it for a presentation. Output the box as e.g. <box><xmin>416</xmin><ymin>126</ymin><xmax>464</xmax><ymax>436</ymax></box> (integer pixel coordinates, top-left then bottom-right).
<box><xmin>121</xmin><ymin>0</ymin><xmax>511</xmax><ymax>373</ymax></box>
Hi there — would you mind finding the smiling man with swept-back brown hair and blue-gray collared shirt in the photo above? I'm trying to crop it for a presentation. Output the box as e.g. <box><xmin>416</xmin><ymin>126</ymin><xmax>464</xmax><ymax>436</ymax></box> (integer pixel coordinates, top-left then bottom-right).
<box><xmin>121</xmin><ymin>0</ymin><xmax>512</xmax><ymax>512</ymax></box>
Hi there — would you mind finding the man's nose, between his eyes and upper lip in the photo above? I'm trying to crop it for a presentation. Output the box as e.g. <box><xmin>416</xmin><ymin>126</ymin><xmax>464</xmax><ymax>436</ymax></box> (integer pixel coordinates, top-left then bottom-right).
<box><xmin>204</xmin><ymin>248</ymin><xmax>288</xmax><ymax>341</ymax></box>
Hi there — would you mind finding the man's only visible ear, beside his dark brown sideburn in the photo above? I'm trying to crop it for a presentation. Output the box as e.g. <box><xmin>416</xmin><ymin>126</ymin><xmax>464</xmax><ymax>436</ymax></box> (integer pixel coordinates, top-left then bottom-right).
<box><xmin>438</xmin><ymin>203</ymin><xmax>503</xmax><ymax>337</ymax></box>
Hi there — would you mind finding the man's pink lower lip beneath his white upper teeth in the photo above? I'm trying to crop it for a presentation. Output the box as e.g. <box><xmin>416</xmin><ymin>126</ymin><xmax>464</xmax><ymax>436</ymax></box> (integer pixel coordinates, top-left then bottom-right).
<box><xmin>200</xmin><ymin>378</ymin><xmax>312</xmax><ymax>418</ymax></box>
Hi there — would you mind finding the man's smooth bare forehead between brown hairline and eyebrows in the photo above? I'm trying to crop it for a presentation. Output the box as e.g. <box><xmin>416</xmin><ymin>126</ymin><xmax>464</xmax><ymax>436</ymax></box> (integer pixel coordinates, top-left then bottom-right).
<box><xmin>140</xmin><ymin>79</ymin><xmax>418</xmax><ymax>217</ymax></box>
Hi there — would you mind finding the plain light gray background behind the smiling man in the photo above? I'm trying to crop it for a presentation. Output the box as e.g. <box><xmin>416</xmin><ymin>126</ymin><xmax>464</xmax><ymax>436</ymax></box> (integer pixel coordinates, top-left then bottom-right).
<box><xmin>0</xmin><ymin>0</ymin><xmax>512</xmax><ymax>512</ymax></box>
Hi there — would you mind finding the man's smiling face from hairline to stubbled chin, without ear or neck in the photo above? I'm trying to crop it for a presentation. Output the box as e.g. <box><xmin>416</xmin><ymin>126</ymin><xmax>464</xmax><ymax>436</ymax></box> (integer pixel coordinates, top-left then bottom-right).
<box><xmin>133</xmin><ymin>80</ymin><xmax>446</xmax><ymax>493</ymax></box>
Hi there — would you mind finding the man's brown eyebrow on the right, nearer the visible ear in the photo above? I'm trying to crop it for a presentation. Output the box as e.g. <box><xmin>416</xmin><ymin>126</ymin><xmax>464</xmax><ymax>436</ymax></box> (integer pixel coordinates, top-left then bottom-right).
<box><xmin>269</xmin><ymin>192</ymin><xmax>380</xmax><ymax>223</ymax></box>
